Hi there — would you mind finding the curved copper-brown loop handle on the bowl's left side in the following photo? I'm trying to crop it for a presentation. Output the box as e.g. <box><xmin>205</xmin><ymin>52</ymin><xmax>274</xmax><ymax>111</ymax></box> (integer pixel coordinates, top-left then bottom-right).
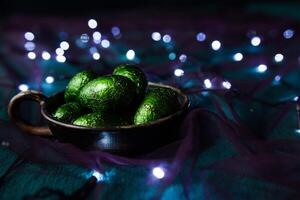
<box><xmin>8</xmin><ymin>90</ymin><xmax>52</xmax><ymax>136</ymax></box>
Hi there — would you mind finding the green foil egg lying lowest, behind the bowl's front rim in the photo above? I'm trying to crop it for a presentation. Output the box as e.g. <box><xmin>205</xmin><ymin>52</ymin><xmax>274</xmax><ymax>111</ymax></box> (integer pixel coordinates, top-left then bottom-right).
<box><xmin>73</xmin><ymin>112</ymin><xmax>131</xmax><ymax>128</ymax></box>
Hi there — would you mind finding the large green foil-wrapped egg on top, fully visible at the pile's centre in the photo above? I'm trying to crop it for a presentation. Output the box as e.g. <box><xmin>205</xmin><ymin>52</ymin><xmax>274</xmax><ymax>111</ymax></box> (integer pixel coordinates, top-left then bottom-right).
<box><xmin>78</xmin><ymin>75</ymin><xmax>136</xmax><ymax>112</ymax></box>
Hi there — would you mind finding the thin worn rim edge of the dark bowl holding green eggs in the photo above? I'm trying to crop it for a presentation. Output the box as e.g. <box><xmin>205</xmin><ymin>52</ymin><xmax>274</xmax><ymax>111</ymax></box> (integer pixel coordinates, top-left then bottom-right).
<box><xmin>41</xmin><ymin>82</ymin><xmax>190</xmax><ymax>131</ymax></box>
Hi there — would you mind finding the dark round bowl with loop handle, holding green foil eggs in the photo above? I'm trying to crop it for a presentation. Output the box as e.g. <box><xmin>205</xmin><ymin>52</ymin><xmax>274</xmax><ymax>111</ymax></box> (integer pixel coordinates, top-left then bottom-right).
<box><xmin>8</xmin><ymin>83</ymin><xmax>189</xmax><ymax>155</ymax></box>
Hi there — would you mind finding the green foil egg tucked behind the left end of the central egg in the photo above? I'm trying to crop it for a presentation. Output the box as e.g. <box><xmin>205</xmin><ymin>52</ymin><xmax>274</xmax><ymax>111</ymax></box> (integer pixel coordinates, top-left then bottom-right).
<box><xmin>65</xmin><ymin>71</ymin><xmax>96</xmax><ymax>102</ymax></box>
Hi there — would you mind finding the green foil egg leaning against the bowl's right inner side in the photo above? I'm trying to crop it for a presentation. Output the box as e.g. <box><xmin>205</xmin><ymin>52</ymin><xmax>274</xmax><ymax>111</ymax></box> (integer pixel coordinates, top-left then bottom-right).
<box><xmin>134</xmin><ymin>88</ymin><xmax>180</xmax><ymax>125</ymax></box>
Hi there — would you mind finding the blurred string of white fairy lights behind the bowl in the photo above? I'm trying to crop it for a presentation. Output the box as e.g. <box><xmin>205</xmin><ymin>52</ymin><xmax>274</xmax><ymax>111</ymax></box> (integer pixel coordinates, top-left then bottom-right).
<box><xmin>18</xmin><ymin>19</ymin><xmax>295</xmax><ymax>96</ymax></box>
